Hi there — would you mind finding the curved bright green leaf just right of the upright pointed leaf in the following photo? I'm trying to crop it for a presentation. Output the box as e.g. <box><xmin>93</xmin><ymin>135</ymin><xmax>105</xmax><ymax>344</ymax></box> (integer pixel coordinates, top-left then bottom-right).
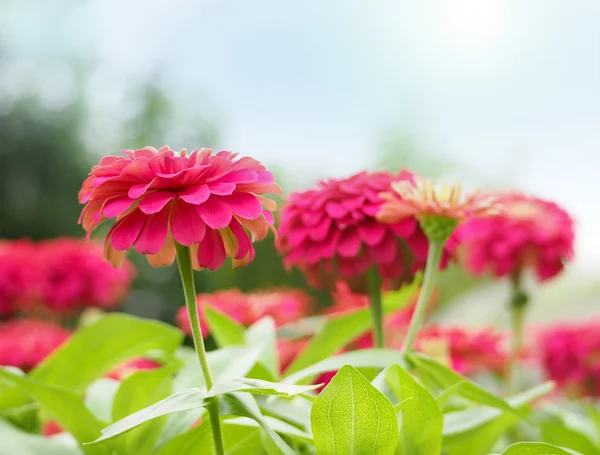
<box><xmin>385</xmin><ymin>365</ymin><xmax>444</xmax><ymax>455</ymax></box>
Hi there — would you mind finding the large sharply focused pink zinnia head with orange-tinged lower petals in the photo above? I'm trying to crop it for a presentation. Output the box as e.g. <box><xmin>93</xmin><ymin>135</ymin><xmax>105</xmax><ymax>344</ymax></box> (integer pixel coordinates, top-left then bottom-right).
<box><xmin>79</xmin><ymin>146</ymin><xmax>281</xmax><ymax>270</ymax></box>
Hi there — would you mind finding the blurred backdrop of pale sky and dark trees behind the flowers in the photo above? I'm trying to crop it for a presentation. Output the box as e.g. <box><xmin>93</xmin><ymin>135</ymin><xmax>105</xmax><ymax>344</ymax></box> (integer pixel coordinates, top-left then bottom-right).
<box><xmin>0</xmin><ymin>0</ymin><xmax>600</xmax><ymax>325</ymax></box>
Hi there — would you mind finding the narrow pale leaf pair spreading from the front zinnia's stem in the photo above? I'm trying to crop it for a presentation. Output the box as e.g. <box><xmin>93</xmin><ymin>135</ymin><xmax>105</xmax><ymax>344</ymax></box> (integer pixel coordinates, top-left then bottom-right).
<box><xmin>94</xmin><ymin>378</ymin><xmax>316</xmax><ymax>443</ymax></box>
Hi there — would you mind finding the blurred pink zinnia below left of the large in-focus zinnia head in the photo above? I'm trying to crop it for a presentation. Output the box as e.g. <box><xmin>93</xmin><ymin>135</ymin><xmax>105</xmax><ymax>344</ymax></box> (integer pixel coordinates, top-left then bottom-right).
<box><xmin>35</xmin><ymin>238</ymin><xmax>135</xmax><ymax>312</ymax></box>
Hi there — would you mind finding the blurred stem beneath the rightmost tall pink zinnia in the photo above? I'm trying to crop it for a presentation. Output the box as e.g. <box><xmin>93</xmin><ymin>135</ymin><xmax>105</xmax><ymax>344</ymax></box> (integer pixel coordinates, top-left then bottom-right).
<box><xmin>506</xmin><ymin>270</ymin><xmax>529</xmax><ymax>395</ymax></box>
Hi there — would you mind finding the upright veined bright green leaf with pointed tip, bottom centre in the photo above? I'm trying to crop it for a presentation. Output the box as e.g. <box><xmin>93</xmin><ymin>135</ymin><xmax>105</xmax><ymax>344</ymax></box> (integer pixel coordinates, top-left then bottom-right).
<box><xmin>311</xmin><ymin>365</ymin><xmax>398</xmax><ymax>455</ymax></box>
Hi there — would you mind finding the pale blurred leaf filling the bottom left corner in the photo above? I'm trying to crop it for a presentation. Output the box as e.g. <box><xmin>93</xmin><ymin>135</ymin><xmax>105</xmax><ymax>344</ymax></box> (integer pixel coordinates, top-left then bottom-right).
<box><xmin>0</xmin><ymin>420</ymin><xmax>83</xmax><ymax>455</ymax></box>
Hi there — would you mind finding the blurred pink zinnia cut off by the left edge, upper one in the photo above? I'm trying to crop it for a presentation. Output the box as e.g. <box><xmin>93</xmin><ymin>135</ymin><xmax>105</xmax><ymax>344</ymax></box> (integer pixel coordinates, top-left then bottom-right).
<box><xmin>0</xmin><ymin>240</ymin><xmax>40</xmax><ymax>317</ymax></box>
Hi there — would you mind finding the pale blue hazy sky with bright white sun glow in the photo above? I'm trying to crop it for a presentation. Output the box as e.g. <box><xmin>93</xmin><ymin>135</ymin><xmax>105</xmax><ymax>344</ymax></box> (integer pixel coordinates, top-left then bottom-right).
<box><xmin>0</xmin><ymin>0</ymin><xmax>600</xmax><ymax>270</ymax></box>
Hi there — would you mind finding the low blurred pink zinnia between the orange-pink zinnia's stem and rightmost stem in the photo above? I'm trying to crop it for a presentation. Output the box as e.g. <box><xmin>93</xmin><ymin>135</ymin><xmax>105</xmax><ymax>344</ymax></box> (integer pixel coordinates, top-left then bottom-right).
<box><xmin>416</xmin><ymin>325</ymin><xmax>507</xmax><ymax>375</ymax></box>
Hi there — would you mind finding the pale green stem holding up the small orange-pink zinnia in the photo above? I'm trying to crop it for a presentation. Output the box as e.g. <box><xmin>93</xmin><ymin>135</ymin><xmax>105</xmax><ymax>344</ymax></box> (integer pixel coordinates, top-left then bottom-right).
<box><xmin>401</xmin><ymin>240</ymin><xmax>446</xmax><ymax>354</ymax></box>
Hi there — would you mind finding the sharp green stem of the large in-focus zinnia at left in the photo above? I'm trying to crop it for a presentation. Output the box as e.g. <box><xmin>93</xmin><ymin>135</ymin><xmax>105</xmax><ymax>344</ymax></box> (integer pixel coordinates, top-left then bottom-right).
<box><xmin>175</xmin><ymin>242</ymin><xmax>225</xmax><ymax>455</ymax></box>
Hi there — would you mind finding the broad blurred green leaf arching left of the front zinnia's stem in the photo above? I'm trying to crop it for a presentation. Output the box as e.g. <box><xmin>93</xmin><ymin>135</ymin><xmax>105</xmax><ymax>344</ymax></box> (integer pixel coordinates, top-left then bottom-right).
<box><xmin>30</xmin><ymin>313</ymin><xmax>183</xmax><ymax>391</ymax></box>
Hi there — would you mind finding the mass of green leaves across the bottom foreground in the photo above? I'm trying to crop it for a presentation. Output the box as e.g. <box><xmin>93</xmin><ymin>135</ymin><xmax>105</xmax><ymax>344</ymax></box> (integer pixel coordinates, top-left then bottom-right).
<box><xmin>0</xmin><ymin>314</ymin><xmax>600</xmax><ymax>455</ymax></box>
